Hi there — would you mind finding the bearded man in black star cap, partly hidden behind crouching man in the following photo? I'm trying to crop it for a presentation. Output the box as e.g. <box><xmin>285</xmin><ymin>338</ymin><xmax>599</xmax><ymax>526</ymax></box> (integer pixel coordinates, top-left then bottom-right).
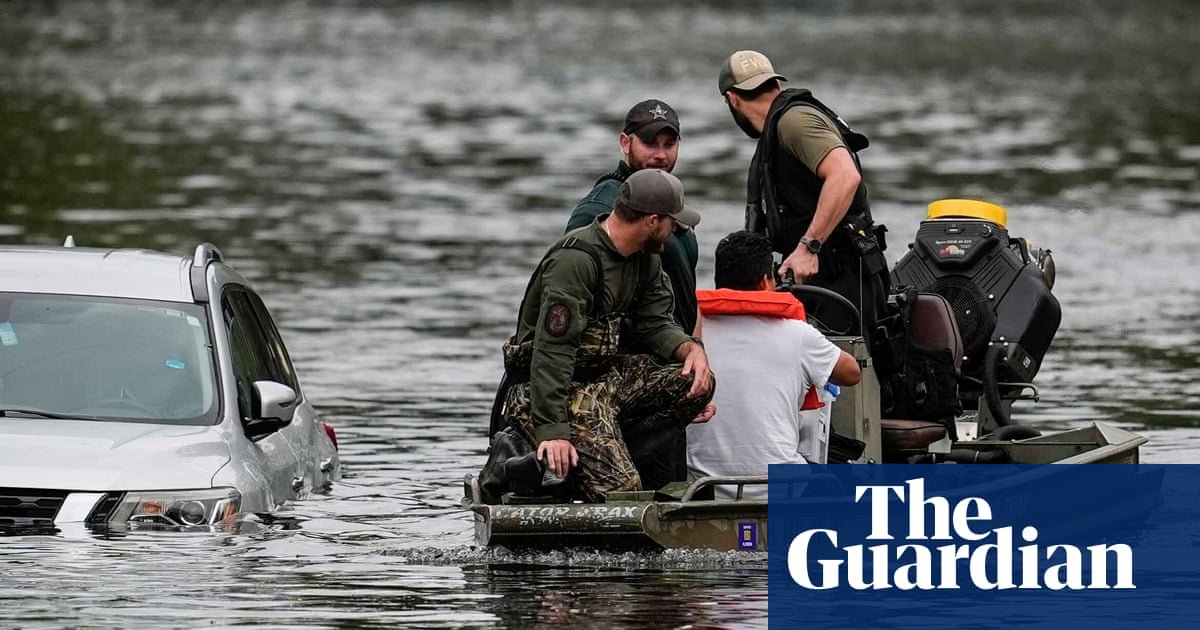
<box><xmin>566</xmin><ymin>98</ymin><xmax>700</xmax><ymax>487</ymax></box>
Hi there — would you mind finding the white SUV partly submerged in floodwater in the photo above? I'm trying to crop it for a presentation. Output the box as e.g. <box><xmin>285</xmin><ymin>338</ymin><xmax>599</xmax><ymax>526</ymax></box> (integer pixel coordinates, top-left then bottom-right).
<box><xmin>0</xmin><ymin>238</ymin><xmax>340</xmax><ymax>532</ymax></box>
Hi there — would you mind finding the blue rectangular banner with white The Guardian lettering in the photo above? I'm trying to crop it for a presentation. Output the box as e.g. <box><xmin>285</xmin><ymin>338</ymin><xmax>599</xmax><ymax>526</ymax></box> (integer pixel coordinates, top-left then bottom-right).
<box><xmin>767</xmin><ymin>464</ymin><xmax>1200</xmax><ymax>630</ymax></box>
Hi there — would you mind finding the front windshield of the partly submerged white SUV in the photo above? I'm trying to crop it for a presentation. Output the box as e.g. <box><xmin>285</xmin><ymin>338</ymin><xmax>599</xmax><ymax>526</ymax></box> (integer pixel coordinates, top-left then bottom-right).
<box><xmin>0</xmin><ymin>293</ymin><xmax>217</xmax><ymax>425</ymax></box>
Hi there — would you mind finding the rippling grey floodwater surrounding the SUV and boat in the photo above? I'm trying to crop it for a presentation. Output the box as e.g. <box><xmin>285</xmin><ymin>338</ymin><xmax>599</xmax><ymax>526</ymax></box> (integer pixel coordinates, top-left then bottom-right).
<box><xmin>0</xmin><ymin>0</ymin><xmax>1200</xmax><ymax>626</ymax></box>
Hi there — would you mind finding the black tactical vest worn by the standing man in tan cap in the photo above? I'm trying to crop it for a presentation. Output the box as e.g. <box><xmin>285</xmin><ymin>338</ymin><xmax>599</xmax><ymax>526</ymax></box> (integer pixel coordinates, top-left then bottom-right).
<box><xmin>746</xmin><ymin>89</ymin><xmax>874</xmax><ymax>256</ymax></box>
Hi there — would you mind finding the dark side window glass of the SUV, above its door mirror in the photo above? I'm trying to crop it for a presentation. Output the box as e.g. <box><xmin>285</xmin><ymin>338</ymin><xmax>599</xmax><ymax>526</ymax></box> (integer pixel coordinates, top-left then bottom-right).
<box><xmin>221</xmin><ymin>287</ymin><xmax>300</xmax><ymax>418</ymax></box>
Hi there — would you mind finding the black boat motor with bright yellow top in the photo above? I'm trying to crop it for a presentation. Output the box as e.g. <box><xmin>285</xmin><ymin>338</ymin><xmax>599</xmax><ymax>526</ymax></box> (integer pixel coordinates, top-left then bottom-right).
<box><xmin>892</xmin><ymin>199</ymin><xmax>1062</xmax><ymax>426</ymax></box>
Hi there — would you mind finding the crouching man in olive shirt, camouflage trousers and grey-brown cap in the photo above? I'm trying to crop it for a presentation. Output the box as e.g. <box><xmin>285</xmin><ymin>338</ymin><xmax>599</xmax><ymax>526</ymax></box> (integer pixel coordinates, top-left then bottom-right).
<box><xmin>503</xmin><ymin>169</ymin><xmax>713</xmax><ymax>500</ymax></box>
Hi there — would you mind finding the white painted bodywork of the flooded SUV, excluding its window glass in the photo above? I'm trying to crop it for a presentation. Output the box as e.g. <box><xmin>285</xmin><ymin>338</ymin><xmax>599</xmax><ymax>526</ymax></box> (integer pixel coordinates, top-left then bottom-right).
<box><xmin>0</xmin><ymin>246</ymin><xmax>340</xmax><ymax>523</ymax></box>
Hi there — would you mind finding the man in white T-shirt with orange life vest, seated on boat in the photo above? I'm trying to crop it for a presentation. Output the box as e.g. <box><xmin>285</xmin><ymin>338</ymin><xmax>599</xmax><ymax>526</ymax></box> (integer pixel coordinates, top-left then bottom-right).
<box><xmin>688</xmin><ymin>232</ymin><xmax>862</xmax><ymax>498</ymax></box>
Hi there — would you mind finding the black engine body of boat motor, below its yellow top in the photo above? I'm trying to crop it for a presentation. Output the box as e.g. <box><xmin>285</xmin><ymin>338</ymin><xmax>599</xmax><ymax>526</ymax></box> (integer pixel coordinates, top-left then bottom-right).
<box><xmin>892</xmin><ymin>218</ymin><xmax>1062</xmax><ymax>382</ymax></box>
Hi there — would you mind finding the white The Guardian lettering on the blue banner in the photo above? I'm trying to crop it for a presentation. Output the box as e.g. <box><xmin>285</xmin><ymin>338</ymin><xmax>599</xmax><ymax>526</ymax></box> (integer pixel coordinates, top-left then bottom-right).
<box><xmin>787</xmin><ymin>479</ymin><xmax>1136</xmax><ymax>590</ymax></box>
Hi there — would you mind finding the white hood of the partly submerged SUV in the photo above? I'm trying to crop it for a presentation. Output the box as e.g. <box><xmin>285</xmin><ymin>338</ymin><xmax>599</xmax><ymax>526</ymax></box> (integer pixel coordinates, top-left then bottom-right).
<box><xmin>0</xmin><ymin>418</ymin><xmax>229</xmax><ymax>491</ymax></box>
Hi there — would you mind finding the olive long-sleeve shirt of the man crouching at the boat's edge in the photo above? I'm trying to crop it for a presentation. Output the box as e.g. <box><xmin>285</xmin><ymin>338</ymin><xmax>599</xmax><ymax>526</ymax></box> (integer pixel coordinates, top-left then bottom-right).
<box><xmin>517</xmin><ymin>215</ymin><xmax>692</xmax><ymax>443</ymax></box>
